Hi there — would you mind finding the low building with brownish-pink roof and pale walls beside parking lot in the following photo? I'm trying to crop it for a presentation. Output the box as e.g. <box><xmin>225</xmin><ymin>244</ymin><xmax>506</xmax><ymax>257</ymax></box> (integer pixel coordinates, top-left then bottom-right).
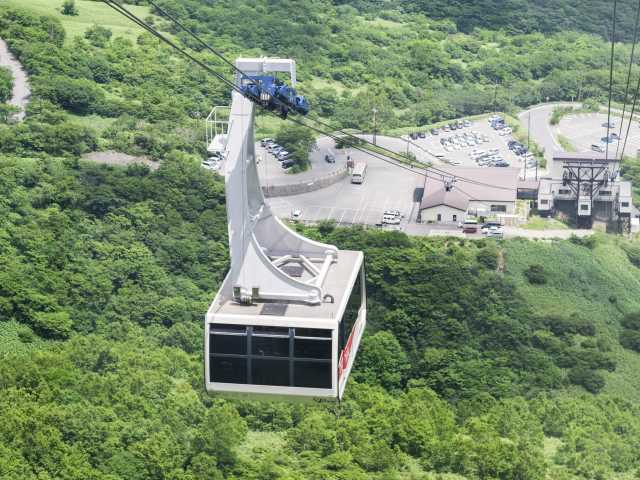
<box><xmin>418</xmin><ymin>167</ymin><xmax>519</xmax><ymax>224</ymax></box>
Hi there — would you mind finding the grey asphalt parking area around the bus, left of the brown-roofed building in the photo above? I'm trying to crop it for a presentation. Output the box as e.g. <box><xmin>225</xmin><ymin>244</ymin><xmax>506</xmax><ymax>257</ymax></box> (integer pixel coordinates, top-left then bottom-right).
<box><xmin>259</xmin><ymin>119</ymin><xmax>536</xmax><ymax>229</ymax></box>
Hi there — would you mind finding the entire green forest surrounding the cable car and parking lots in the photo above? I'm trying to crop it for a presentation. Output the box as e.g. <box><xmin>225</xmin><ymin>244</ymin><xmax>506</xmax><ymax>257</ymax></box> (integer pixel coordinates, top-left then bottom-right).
<box><xmin>0</xmin><ymin>0</ymin><xmax>640</xmax><ymax>480</ymax></box>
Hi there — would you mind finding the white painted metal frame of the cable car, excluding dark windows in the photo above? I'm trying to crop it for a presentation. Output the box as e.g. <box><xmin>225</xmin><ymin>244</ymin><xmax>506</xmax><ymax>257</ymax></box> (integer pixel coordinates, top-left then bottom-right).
<box><xmin>204</xmin><ymin>58</ymin><xmax>366</xmax><ymax>398</ymax></box>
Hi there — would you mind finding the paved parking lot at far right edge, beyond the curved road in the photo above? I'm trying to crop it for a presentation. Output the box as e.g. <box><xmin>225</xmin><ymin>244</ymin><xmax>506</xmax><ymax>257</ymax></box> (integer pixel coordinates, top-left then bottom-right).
<box><xmin>556</xmin><ymin>113</ymin><xmax>640</xmax><ymax>156</ymax></box>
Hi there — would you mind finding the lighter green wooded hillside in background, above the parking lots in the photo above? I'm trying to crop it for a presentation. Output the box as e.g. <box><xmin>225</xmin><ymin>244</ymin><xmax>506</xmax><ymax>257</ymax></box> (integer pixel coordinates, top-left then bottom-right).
<box><xmin>0</xmin><ymin>0</ymin><xmax>640</xmax><ymax>163</ymax></box>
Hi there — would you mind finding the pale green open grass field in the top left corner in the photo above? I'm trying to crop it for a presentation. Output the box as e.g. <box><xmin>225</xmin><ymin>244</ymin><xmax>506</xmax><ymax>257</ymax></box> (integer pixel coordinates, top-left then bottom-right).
<box><xmin>0</xmin><ymin>0</ymin><xmax>150</xmax><ymax>41</ymax></box>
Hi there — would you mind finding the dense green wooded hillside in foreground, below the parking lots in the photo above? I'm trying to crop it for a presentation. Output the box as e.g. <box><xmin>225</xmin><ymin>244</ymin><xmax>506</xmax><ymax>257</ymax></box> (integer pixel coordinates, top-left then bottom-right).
<box><xmin>0</xmin><ymin>157</ymin><xmax>640</xmax><ymax>480</ymax></box>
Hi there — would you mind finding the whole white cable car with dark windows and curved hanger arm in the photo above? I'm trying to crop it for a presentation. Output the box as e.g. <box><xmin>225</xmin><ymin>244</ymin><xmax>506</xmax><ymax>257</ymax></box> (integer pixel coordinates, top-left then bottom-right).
<box><xmin>204</xmin><ymin>58</ymin><xmax>367</xmax><ymax>399</ymax></box>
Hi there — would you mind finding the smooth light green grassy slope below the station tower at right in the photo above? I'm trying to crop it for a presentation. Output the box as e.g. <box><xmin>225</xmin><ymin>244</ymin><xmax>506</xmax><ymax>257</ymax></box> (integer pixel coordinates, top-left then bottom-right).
<box><xmin>504</xmin><ymin>235</ymin><xmax>640</xmax><ymax>401</ymax></box>
